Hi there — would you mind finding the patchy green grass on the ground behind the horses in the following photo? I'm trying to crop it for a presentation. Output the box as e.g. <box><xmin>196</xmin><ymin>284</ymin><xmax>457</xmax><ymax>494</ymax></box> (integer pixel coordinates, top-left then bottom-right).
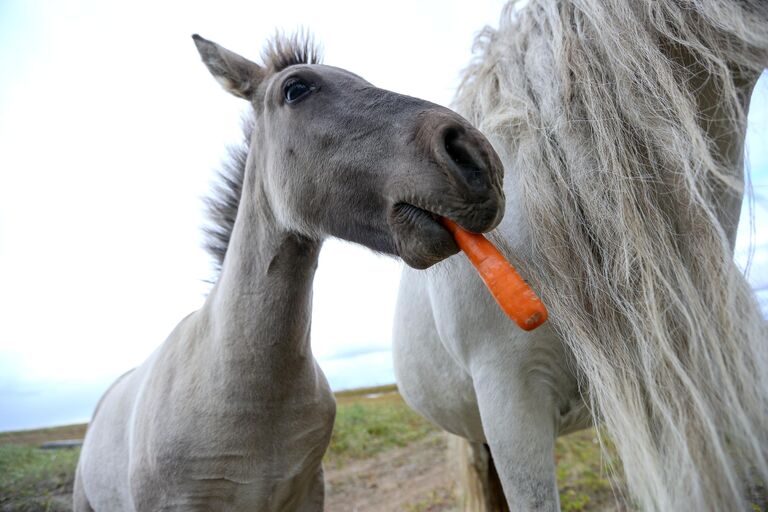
<box><xmin>0</xmin><ymin>385</ymin><xmax>628</xmax><ymax>512</ymax></box>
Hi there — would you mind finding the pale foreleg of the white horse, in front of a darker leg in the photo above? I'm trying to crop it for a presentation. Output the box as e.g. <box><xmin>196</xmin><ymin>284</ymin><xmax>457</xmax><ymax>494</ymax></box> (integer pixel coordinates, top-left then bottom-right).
<box><xmin>473</xmin><ymin>364</ymin><xmax>560</xmax><ymax>511</ymax></box>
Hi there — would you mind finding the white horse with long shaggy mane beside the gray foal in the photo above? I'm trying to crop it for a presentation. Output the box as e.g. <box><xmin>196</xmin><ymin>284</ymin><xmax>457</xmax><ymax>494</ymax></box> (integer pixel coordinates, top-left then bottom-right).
<box><xmin>394</xmin><ymin>0</ymin><xmax>768</xmax><ymax>511</ymax></box>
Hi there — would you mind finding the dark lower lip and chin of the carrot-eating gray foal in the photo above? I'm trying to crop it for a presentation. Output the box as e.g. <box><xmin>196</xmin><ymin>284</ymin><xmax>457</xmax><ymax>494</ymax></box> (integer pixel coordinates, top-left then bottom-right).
<box><xmin>389</xmin><ymin>203</ymin><xmax>459</xmax><ymax>269</ymax></box>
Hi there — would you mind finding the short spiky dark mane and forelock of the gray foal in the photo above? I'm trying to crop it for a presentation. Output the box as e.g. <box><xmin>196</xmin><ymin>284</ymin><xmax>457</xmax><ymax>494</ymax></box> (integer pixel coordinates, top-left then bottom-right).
<box><xmin>203</xmin><ymin>31</ymin><xmax>321</xmax><ymax>282</ymax></box>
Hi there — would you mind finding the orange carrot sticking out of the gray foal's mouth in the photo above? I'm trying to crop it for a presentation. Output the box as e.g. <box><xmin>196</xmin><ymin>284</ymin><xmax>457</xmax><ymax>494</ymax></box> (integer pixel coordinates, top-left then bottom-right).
<box><xmin>440</xmin><ymin>217</ymin><xmax>547</xmax><ymax>331</ymax></box>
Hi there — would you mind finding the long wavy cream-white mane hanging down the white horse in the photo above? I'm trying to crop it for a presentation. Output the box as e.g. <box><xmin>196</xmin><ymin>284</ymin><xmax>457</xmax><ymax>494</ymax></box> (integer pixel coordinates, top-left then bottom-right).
<box><xmin>456</xmin><ymin>0</ymin><xmax>768</xmax><ymax>510</ymax></box>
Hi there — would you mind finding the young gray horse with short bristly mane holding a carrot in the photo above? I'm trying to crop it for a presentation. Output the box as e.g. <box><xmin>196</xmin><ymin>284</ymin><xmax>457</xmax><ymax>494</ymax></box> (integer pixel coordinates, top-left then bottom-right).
<box><xmin>74</xmin><ymin>36</ymin><xmax>504</xmax><ymax>512</ymax></box>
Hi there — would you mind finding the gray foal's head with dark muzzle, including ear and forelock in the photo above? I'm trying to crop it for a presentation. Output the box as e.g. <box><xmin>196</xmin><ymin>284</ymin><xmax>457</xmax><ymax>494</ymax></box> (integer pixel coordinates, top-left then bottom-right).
<box><xmin>194</xmin><ymin>36</ymin><xmax>504</xmax><ymax>268</ymax></box>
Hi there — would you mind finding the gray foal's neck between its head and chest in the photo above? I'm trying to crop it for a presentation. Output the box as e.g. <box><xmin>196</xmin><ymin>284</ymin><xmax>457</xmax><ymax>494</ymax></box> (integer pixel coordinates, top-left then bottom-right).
<box><xmin>201</xmin><ymin>168</ymin><xmax>321</xmax><ymax>371</ymax></box>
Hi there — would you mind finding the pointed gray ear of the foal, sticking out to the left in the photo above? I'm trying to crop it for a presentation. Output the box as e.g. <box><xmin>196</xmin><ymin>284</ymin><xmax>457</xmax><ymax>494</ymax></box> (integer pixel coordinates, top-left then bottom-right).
<box><xmin>192</xmin><ymin>34</ymin><xmax>265</xmax><ymax>100</ymax></box>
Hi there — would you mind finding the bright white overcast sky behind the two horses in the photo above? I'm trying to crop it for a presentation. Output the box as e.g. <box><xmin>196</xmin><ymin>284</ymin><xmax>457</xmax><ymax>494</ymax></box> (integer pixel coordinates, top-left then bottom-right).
<box><xmin>0</xmin><ymin>0</ymin><xmax>768</xmax><ymax>430</ymax></box>
